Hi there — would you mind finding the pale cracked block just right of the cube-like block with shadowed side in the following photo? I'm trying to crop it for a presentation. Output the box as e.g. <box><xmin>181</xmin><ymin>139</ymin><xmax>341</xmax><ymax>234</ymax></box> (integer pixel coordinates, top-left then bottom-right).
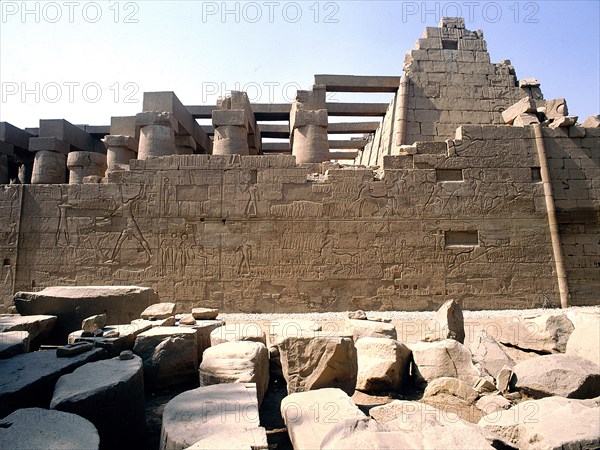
<box><xmin>409</xmin><ymin>339</ymin><xmax>480</xmax><ymax>386</ymax></box>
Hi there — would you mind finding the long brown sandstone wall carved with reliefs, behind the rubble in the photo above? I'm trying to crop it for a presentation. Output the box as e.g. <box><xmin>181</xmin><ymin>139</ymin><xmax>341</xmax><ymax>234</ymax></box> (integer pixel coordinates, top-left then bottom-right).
<box><xmin>0</xmin><ymin>125</ymin><xmax>600</xmax><ymax>312</ymax></box>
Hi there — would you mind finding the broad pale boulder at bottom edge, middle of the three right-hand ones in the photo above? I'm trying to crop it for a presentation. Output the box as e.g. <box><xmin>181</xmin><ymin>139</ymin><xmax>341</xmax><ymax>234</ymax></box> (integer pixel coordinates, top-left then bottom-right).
<box><xmin>364</xmin><ymin>400</ymin><xmax>493</xmax><ymax>450</ymax></box>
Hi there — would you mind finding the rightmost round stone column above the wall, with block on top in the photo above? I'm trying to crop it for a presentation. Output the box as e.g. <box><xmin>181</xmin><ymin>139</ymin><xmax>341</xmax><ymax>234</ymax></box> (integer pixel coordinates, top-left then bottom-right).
<box><xmin>290</xmin><ymin>86</ymin><xmax>330</xmax><ymax>164</ymax></box>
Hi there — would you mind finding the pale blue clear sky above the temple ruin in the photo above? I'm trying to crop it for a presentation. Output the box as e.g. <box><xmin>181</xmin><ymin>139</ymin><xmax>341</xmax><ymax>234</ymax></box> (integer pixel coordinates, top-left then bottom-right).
<box><xmin>0</xmin><ymin>0</ymin><xmax>600</xmax><ymax>127</ymax></box>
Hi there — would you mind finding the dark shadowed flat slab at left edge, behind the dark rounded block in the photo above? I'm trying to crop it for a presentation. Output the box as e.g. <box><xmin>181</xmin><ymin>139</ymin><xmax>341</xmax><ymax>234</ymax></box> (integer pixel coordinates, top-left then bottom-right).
<box><xmin>0</xmin><ymin>348</ymin><xmax>107</xmax><ymax>417</ymax></box>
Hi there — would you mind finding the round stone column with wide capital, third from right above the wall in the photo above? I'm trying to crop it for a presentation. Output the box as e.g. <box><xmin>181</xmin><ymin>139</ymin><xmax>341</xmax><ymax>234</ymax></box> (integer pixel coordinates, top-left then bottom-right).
<box><xmin>135</xmin><ymin>111</ymin><xmax>178</xmax><ymax>159</ymax></box>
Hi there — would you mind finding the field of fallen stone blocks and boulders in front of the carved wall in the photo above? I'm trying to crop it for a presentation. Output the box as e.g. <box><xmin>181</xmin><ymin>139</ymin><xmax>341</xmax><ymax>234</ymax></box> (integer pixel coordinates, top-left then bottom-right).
<box><xmin>0</xmin><ymin>288</ymin><xmax>600</xmax><ymax>449</ymax></box>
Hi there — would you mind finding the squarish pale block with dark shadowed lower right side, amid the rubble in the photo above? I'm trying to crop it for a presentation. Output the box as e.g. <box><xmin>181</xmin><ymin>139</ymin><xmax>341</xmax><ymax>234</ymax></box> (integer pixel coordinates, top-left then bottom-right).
<box><xmin>355</xmin><ymin>337</ymin><xmax>410</xmax><ymax>391</ymax></box>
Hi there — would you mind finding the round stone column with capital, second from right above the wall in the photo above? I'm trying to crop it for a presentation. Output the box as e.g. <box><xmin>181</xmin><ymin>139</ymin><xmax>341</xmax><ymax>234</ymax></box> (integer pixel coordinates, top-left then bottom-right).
<box><xmin>212</xmin><ymin>109</ymin><xmax>250</xmax><ymax>155</ymax></box>
